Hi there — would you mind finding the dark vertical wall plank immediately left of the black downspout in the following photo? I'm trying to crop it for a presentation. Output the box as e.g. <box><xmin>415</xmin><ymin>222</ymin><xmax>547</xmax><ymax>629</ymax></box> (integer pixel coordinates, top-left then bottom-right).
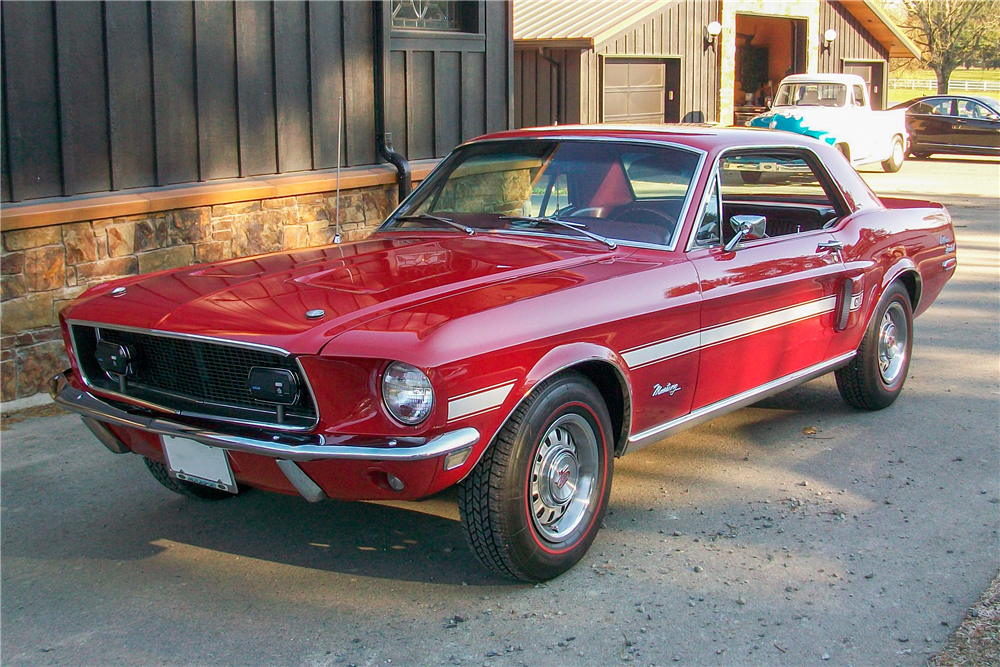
<box><xmin>343</xmin><ymin>2</ymin><xmax>375</xmax><ymax>165</ymax></box>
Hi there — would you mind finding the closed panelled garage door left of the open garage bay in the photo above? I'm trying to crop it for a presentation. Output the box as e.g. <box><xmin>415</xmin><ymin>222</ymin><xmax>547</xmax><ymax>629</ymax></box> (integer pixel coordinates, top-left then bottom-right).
<box><xmin>602</xmin><ymin>58</ymin><xmax>680</xmax><ymax>124</ymax></box>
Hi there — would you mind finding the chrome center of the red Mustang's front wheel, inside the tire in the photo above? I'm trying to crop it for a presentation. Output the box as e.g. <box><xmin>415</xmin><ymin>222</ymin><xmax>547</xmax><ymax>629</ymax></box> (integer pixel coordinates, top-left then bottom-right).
<box><xmin>529</xmin><ymin>413</ymin><xmax>597</xmax><ymax>542</ymax></box>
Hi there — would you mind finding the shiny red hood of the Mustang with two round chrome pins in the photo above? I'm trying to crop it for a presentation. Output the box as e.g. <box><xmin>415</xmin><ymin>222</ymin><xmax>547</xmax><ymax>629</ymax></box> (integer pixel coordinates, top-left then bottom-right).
<box><xmin>63</xmin><ymin>233</ymin><xmax>615</xmax><ymax>354</ymax></box>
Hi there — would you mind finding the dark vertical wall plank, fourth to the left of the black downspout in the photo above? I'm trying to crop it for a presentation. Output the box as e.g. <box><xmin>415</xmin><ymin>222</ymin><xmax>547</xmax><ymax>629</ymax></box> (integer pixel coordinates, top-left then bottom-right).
<box><xmin>236</xmin><ymin>2</ymin><xmax>277</xmax><ymax>176</ymax></box>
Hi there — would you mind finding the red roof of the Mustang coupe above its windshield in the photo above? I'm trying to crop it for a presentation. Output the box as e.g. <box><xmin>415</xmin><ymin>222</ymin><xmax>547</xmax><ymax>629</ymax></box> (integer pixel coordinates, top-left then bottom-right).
<box><xmin>468</xmin><ymin>124</ymin><xmax>821</xmax><ymax>151</ymax></box>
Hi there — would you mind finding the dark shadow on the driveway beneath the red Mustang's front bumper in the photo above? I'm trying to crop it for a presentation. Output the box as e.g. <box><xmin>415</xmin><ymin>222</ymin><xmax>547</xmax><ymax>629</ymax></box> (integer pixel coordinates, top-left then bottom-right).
<box><xmin>4</xmin><ymin>457</ymin><xmax>517</xmax><ymax>586</ymax></box>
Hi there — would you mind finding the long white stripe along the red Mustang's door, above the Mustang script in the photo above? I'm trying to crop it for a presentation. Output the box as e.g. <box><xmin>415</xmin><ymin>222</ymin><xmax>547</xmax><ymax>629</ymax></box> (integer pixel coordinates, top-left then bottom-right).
<box><xmin>622</xmin><ymin>296</ymin><xmax>837</xmax><ymax>368</ymax></box>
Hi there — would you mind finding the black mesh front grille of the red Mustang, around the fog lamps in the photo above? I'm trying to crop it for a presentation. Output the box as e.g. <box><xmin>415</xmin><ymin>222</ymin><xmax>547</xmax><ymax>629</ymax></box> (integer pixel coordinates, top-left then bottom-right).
<box><xmin>73</xmin><ymin>324</ymin><xmax>316</xmax><ymax>427</ymax></box>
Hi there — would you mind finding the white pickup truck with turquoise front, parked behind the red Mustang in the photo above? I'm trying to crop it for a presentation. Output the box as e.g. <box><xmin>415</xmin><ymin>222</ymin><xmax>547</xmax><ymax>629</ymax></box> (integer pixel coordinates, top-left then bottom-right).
<box><xmin>747</xmin><ymin>74</ymin><xmax>907</xmax><ymax>172</ymax></box>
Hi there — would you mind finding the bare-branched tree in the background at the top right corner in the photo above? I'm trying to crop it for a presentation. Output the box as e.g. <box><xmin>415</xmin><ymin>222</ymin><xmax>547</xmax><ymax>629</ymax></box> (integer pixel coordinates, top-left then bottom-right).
<box><xmin>903</xmin><ymin>0</ymin><xmax>1000</xmax><ymax>94</ymax></box>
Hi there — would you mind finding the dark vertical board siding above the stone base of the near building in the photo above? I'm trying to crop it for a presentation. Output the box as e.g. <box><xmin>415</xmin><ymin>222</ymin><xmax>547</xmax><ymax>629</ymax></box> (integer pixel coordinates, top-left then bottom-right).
<box><xmin>0</xmin><ymin>1</ymin><xmax>512</xmax><ymax>202</ymax></box>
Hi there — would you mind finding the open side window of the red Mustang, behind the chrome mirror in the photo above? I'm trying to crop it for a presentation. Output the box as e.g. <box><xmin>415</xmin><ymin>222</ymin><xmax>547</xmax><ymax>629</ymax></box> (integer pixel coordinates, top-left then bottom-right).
<box><xmin>719</xmin><ymin>149</ymin><xmax>840</xmax><ymax>242</ymax></box>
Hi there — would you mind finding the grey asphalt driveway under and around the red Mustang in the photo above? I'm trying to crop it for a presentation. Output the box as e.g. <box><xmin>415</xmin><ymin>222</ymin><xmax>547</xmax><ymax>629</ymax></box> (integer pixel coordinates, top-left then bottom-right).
<box><xmin>0</xmin><ymin>159</ymin><xmax>1000</xmax><ymax>665</ymax></box>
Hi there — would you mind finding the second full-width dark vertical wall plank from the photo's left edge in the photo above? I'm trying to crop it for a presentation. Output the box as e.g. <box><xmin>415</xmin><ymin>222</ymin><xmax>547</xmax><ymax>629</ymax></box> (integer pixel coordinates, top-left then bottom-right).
<box><xmin>56</xmin><ymin>1</ymin><xmax>111</xmax><ymax>195</ymax></box>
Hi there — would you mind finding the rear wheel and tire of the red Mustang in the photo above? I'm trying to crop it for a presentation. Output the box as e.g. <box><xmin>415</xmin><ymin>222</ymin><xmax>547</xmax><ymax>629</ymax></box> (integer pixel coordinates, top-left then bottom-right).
<box><xmin>836</xmin><ymin>282</ymin><xmax>913</xmax><ymax>410</ymax></box>
